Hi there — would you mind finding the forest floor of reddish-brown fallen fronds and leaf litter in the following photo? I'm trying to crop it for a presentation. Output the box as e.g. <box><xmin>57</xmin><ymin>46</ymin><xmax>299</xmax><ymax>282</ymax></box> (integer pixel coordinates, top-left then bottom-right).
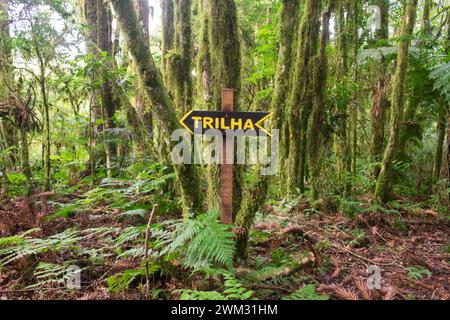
<box><xmin>0</xmin><ymin>189</ymin><xmax>450</xmax><ymax>300</ymax></box>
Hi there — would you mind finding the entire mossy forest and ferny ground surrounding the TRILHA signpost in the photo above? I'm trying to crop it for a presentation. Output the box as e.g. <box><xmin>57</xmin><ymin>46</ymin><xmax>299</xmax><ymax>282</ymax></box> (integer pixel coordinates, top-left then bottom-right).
<box><xmin>0</xmin><ymin>0</ymin><xmax>450</xmax><ymax>299</ymax></box>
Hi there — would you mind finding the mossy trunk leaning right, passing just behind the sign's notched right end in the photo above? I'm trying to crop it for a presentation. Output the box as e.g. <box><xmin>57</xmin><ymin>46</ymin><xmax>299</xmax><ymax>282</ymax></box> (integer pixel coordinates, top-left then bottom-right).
<box><xmin>235</xmin><ymin>0</ymin><xmax>299</xmax><ymax>258</ymax></box>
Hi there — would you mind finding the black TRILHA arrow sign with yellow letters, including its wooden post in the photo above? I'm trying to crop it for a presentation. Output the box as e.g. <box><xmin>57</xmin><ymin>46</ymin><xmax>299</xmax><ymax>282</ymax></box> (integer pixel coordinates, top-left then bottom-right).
<box><xmin>180</xmin><ymin>89</ymin><xmax>272</xmax><ymax>224</ymax></box>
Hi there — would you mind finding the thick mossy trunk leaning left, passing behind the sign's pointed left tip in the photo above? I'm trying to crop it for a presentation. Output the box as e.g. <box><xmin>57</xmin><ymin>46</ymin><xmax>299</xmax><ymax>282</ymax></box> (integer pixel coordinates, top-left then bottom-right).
<box><xmin>111</xmin><ymin>0</ymin><xmax>202</xmax><ymax>213</ymax></box>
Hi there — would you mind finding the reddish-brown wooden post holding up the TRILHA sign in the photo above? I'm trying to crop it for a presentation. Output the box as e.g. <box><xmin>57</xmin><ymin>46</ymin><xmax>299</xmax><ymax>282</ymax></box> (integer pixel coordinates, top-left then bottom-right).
<box><xmin>220</xmin><ymin>89</ymin><xmax>234</xmax><ymax>224</ymax></box>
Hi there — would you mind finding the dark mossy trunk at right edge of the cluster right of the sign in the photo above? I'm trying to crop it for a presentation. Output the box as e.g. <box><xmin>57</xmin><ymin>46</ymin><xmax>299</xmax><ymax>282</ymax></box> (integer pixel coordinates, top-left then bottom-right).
<box><xmin>308</xmin><ymin>0</ymin><xmax>334</xmax><ymax>201</ymax></box>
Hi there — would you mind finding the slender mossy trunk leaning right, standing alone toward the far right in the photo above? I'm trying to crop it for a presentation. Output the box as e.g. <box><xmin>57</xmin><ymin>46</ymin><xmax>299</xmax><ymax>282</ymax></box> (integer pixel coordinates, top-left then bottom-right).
<box><xmin>374</xmin><ymin>0</ymin><xmax>418</xmax><ymax>203</ymax></box>
